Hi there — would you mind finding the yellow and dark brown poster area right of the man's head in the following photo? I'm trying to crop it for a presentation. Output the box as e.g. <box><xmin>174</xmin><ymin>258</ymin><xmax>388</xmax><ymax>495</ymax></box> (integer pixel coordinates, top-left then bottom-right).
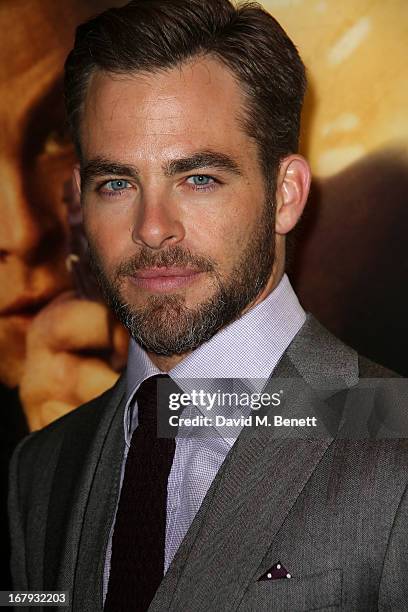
<box><xmin>264</xmin><ymin>0</ymin><xmax>408</xmax><ymax>375</ymax></box>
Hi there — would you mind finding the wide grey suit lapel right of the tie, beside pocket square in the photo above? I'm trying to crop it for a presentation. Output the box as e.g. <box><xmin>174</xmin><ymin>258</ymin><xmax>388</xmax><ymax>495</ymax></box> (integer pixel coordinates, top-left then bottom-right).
<box><xmin>150</xmin><ymin>318</ymin><xmax>357</xmax><ymax>612</ymax></box>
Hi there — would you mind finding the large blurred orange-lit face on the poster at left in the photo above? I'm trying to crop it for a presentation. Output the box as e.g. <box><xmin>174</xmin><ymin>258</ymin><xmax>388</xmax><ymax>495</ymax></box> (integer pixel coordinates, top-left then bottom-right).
<box><xmin>0</xmin><ymin>0</ymin><xmax>83</xmax><ymax>386</ymax></box>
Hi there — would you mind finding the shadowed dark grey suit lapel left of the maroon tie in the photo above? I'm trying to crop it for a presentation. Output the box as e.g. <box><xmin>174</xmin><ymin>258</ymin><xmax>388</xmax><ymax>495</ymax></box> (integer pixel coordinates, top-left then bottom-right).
<box><xmin>44</xmin><ymin>377</ymin><xmax>125</xmax><ymax>593</ymax></box>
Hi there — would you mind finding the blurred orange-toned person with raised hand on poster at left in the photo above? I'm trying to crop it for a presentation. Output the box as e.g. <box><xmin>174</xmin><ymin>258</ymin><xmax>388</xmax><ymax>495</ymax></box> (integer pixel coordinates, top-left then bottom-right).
<box><xmin>0</xmin><ymin>0</ymin><xmax>127</xmax><ymax>588</ymax></box>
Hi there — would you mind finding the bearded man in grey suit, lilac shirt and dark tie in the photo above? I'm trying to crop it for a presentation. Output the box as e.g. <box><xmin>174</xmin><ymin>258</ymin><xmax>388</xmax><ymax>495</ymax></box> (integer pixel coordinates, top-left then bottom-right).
<box><xmin>10</xmin><ymin>0</ymin><xmax>408</xmax><ymax>611</ymax></box>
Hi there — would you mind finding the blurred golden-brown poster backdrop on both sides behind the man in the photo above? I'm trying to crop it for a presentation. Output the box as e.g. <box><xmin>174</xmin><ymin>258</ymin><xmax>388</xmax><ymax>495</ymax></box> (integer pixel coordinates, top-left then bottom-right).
<box><xmin>0</xmin><ymin>0</ymin><xmax>408</xmax><ymax>589</ymax></box>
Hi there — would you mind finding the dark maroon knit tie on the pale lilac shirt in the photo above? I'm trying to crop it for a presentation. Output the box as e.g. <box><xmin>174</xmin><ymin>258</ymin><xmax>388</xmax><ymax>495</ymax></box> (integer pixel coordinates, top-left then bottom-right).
<box><xmin>104</xmin><ymin>375</ymin><xmax>176</xmax><ymax>612</ymax></box>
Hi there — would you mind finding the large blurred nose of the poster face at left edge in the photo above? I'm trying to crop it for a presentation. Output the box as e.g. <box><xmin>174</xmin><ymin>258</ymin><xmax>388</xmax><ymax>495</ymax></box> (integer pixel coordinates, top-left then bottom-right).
<box><xmin>0</xmin><ymin>159</ymin><xmax>61</xmax><ymax>260</ymax></box>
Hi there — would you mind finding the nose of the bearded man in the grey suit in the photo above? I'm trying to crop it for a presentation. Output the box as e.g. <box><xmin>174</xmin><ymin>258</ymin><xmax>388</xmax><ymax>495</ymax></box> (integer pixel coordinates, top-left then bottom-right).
<box><xmin>132</xmin><ymin>188</ymin><xmax>185</xmax><ymax>250</ymax></box>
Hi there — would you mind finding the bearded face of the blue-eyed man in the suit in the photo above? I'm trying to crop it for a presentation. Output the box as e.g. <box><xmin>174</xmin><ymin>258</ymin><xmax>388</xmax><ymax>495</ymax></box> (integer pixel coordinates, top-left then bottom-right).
<box><xmin>81</xmin><ymin>58</ymin><xmax>280</xmax><ymax>355</ymax></box>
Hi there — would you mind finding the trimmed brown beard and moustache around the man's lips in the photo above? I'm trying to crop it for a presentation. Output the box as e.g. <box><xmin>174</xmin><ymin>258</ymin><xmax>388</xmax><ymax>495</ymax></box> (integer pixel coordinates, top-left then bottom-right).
<box><xmin>89</xmin><ymin>200</ymin><xmax>275</xmax><ymax>356</ymax></box>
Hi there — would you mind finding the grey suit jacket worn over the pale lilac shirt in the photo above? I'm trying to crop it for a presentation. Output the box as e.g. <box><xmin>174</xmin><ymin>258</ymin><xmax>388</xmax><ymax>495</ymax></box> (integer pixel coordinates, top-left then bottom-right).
<box><xmin>9</xmin><ymin>317</ymin><xmax>408</xmax><ymax>612</ymax></box>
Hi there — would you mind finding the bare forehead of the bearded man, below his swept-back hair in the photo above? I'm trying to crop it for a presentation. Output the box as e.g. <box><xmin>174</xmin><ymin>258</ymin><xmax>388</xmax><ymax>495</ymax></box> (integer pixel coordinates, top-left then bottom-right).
<box><xmin>81</xmin><ymin>57</ymin><xmax>255</xmax><ymax>161</ymax></box>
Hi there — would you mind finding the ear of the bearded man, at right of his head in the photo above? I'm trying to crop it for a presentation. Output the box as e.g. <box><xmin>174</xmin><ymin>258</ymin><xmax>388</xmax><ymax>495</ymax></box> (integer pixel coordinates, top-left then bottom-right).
<box><xmin>275</xmin><ymin>155</ymin><xmax>311</xmax><ymax>235</ymax></box>
